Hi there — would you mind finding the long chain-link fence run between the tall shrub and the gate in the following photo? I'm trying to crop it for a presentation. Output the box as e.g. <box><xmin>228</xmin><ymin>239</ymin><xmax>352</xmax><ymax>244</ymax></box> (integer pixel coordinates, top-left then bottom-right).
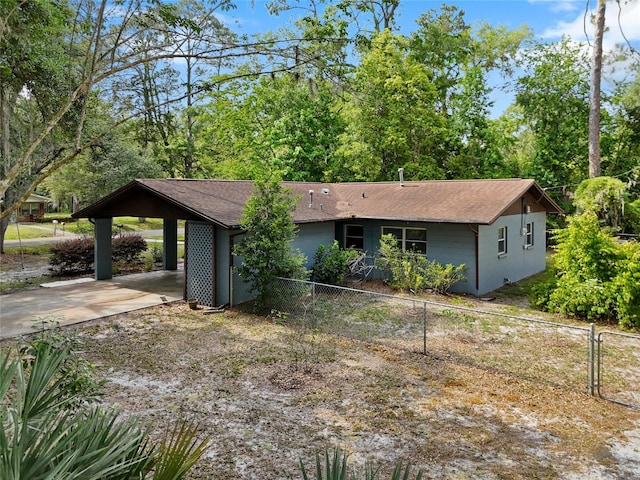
<box><xmin>269</xmin><ymin>279</ymin><xmax>595</xmax><ymax>394</ymax></box>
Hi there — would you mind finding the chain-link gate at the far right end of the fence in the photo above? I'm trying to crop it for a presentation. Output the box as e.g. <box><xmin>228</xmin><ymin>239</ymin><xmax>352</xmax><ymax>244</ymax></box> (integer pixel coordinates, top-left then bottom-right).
<box><xmin>596</xmin><ymin>331</ymin><xmax>640</xmax><ymax>409</ymax></box>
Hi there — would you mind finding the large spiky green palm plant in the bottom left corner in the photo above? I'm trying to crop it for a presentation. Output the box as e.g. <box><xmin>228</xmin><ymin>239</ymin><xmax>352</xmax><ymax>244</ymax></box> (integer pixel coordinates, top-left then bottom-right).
<box><xmin>0</xmin><ymin>340</ymin><xmax>207</xmax><ymax>480</ymax></box>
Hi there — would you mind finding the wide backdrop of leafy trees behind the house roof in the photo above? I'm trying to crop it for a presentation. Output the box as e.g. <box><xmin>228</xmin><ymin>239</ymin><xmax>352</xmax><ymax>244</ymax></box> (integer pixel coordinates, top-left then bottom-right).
<box><xmin>0</xmin><ymin>0</ymin><xmax>640</xmax><ymax>247</ymax></box>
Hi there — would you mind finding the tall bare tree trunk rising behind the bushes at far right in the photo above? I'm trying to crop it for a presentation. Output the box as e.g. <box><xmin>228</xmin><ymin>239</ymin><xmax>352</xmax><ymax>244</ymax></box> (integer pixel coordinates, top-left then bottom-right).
<box><xmin>589</xmin><ymin>0</ymin><xmax>607</xmax><ymax>178</ymax></box>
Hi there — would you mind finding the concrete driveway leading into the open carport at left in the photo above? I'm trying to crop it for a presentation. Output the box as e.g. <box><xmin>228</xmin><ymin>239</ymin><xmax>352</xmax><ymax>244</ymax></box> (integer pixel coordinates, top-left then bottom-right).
<box><xmin>0</xmin><ymin>264</ymin><xmax>184</xmax><ymax>338</ymax></box>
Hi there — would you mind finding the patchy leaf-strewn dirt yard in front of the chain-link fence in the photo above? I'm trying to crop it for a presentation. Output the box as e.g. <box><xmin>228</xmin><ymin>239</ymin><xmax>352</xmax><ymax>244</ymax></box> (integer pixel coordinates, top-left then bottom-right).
<box><xmin>37</xmin><ymin>303</ymin><xmax>640</xmax><ymax>480</ymax></box>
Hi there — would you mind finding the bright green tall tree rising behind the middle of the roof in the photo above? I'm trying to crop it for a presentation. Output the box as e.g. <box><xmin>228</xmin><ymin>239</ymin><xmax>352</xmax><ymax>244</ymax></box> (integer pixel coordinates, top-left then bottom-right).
<box><xmin>334</xmin><ymin>30</ymin><xmax>444</xmax><ymax>181</ymax></box>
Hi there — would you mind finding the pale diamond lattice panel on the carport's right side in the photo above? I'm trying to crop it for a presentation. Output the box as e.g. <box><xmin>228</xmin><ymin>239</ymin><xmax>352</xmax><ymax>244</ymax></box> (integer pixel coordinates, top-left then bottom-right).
<box><xmin>186</xmin><ymin>222</ymin><xmax>216</xmax><ymax>307</ymax></box>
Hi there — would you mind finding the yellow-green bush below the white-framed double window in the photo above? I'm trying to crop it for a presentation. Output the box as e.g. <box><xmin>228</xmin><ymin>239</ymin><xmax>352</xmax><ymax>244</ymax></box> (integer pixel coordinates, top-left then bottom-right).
<box><xmin>376</xmin><ymin>234</ymin><xmax>466</xmax><ymax>293</ymax></box>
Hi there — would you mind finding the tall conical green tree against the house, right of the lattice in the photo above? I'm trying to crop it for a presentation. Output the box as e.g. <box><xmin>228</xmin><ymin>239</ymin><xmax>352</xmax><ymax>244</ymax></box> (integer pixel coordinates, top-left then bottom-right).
<box><xmin>233</xmin><ymin>179</ymin><xmax>308</xmax><ymax>308</ymax></box>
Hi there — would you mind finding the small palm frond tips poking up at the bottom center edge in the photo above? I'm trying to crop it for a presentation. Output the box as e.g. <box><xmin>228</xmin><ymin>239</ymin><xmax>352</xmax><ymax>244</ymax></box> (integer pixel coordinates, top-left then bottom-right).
<box><xmin>300</xmin><ymin>447</ymin><xmax>422</xmax><ymax>480</ymax></box>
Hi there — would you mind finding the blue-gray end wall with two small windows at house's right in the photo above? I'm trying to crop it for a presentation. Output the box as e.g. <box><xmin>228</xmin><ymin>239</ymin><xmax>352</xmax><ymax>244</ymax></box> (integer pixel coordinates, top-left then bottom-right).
<box><xmin>478</xmin><ymin>212</ymin><xmax>546</xmax><ymax>295</ymax></box>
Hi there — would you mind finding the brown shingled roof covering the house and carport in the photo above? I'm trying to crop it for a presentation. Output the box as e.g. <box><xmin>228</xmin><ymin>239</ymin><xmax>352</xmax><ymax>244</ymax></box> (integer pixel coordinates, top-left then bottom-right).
<box><xmin>73</xmin><ymin>179</ymin><xmax>562</xmax><ymax>228</ymax></box>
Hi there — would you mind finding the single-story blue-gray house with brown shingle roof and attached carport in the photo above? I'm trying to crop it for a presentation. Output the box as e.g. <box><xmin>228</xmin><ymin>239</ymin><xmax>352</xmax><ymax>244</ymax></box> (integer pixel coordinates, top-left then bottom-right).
<box><xmin>73</xmin><ymin>179</ymin><xmax>562</xmax><ymax>306</ymax></box>
